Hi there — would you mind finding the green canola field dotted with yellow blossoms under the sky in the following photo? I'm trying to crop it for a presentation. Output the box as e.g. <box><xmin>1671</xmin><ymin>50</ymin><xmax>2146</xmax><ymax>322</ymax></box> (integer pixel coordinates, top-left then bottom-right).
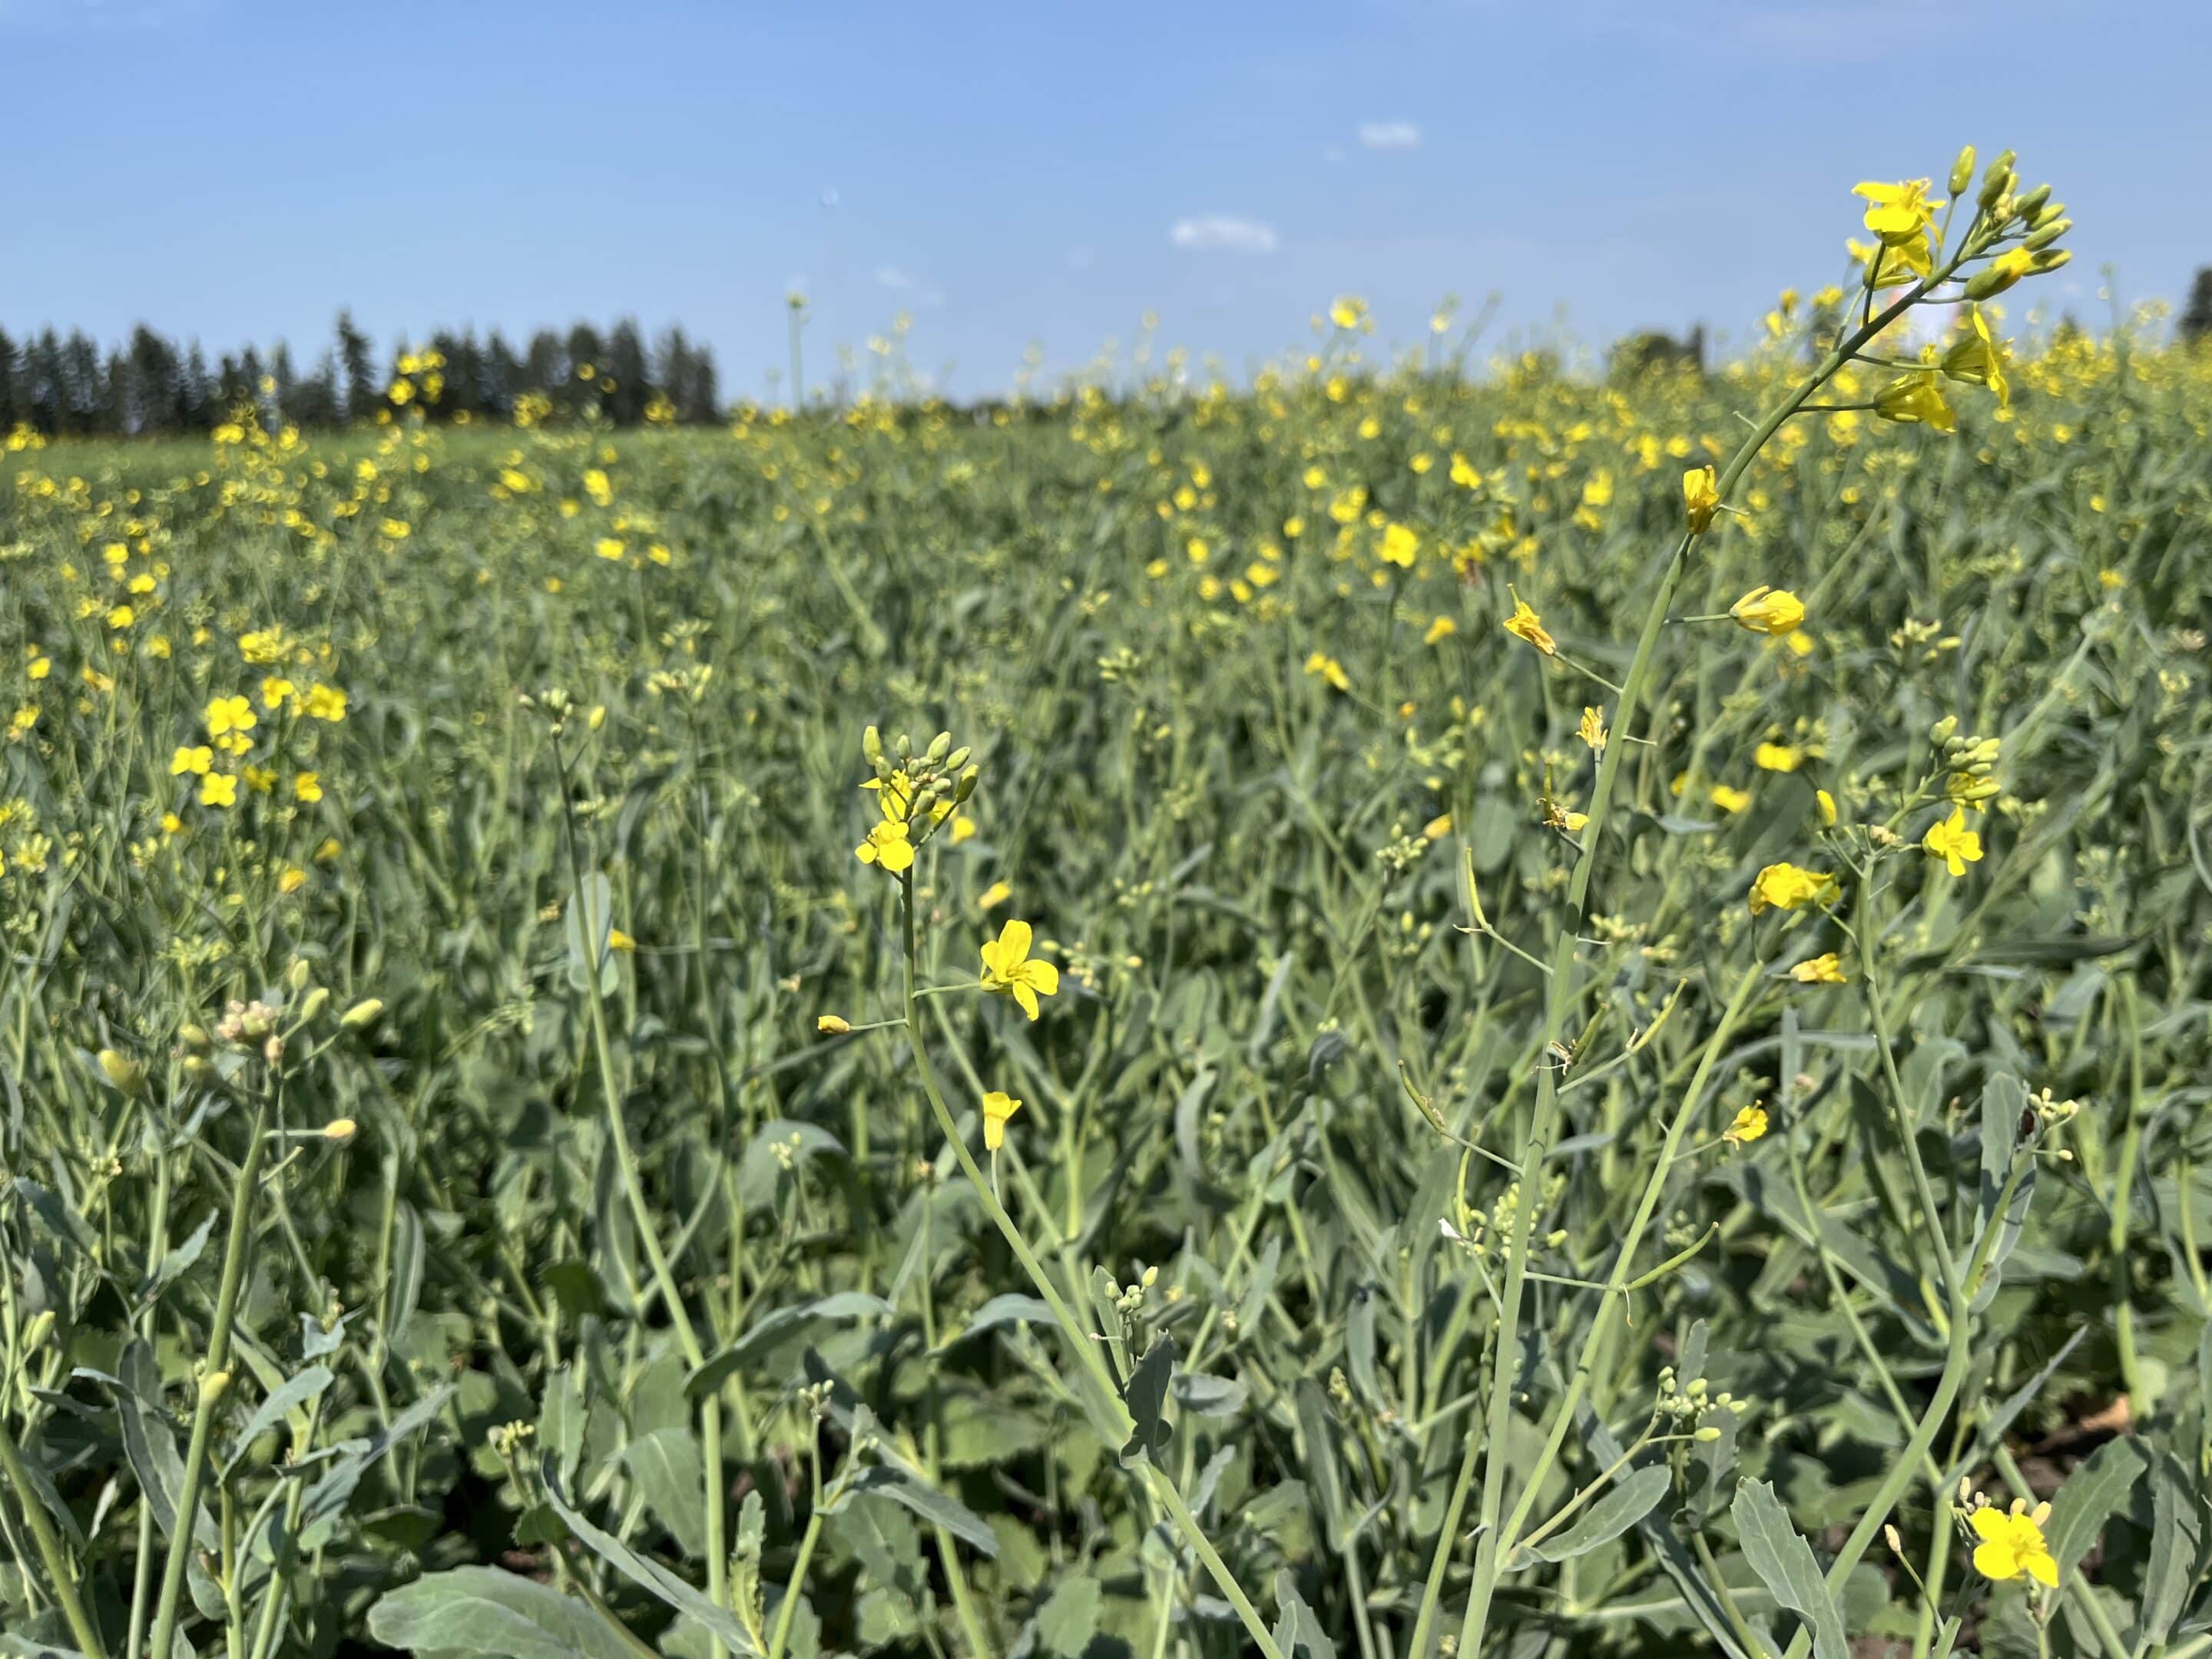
<box><xmin>0</xmin><ymin>157</ymin><xmax>2212</xmax><ymax>1659</ymax></box>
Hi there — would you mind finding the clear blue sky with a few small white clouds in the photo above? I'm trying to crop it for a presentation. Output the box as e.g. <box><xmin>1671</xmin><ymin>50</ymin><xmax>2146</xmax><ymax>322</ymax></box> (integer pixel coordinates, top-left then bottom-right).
<box><xmin>0</xmin><ymin>0</ymin><xmax>2212</xmax><ymax>396</ymax></box>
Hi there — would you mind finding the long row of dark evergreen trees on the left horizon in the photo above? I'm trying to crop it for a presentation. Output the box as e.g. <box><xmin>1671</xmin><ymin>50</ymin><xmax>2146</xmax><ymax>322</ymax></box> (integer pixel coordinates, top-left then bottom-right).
<box><xmin>0</xmin><ymin>312</ymin><xmax>721</xmax><ymax>438</ymax></box>
